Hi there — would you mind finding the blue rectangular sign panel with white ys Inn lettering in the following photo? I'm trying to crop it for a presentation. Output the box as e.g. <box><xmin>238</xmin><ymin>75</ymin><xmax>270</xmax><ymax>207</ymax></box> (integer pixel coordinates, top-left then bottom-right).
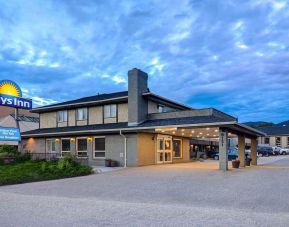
<box><xmin>0</xmin><ymin>94</ymin><xmax>32</xmax><ymax>110</ymax></box>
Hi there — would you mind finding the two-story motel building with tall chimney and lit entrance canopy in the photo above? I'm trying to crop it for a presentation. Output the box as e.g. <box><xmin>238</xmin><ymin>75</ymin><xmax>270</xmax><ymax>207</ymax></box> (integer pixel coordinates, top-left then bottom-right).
<box><xmin>22</xmin><ymin>69</ymin><xmax>264</xmax><ymax>170</ymax></box>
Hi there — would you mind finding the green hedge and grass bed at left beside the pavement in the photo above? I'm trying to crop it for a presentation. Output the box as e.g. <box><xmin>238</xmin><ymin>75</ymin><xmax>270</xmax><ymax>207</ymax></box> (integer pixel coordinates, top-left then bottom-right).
<box><xmin>0</xmin><ymin>157</ymin><xmax>92</xmax><ymax>185</ymax></box>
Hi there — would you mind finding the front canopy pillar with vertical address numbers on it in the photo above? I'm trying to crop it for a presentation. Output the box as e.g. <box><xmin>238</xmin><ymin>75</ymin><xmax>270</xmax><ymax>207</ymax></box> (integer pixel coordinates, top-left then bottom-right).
<box><xmin>219</xmin><ymin>128</ymin><xmax>228</xmax><ymax>171</ymax></box>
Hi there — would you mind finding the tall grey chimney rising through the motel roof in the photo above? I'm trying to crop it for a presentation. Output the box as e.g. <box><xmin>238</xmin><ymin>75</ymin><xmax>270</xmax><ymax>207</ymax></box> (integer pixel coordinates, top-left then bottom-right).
<box><xmin>128</xmin><ymin>68</ymin><xmax>148</xmax><ymax>126</ymax></box>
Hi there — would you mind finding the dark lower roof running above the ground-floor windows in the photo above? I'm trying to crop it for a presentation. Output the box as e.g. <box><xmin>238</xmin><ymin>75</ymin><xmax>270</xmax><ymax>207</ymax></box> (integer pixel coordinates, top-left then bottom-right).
<box><xmin>22</xmin><ymin>116</ymin><xmax>232</xmax><ymax>137</ymax></box>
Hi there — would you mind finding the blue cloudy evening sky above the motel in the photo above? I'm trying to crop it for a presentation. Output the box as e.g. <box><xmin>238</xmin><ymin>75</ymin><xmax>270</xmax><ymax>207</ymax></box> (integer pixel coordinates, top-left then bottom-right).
<box><xmin>0</xmin><ymin>0</ymin><xmax>289</xmax><ymax>122</ymax></box>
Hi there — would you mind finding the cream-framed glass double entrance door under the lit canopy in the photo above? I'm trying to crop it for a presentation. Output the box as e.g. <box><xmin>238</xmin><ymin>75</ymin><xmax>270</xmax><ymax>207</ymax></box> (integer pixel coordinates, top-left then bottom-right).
<box><xmin>157</xmin><ymin>135</ymin><xmax>173</xmax><ymax>164</ymax></box>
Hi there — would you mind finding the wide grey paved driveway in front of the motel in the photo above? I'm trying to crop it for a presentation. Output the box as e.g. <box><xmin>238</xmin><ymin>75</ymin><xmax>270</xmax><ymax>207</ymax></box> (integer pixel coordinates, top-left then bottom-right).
<box><xmin>0</xmin><ymin>156</ymin><xmax>289</xmax><ymax>226</ymax></box>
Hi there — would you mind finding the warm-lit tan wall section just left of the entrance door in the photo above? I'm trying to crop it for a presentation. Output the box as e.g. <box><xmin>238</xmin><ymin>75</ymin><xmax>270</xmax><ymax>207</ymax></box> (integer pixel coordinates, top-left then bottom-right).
<box><xmin>137</xmin><ymin>133</ymin><xmax>156</xmax><ymax>166</ymax></box>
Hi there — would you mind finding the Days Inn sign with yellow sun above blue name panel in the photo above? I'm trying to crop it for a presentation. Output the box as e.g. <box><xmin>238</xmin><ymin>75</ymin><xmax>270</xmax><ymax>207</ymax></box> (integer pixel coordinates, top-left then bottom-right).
<box><xmin>0</xmin><ymin>80</ymin><xmax>32</xmax><ymax>110</ymax></box>
